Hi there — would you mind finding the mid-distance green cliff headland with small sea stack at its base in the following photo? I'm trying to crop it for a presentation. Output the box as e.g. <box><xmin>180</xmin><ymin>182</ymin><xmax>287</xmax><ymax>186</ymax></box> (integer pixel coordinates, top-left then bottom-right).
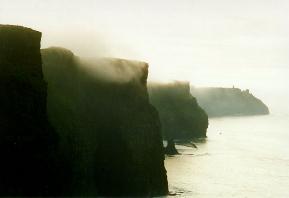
<box><xmin>148</xmin><ymin>82</ymin><xmax>208</xmax><ymax>139</ymax></box>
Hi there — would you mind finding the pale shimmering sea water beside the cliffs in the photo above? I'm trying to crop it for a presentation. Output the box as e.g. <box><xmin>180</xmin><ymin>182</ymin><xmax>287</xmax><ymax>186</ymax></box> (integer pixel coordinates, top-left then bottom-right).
<box><xmin>165</xmin><ymin>114</ymin><xmax>289</xmax><ymax>198</ymax></box>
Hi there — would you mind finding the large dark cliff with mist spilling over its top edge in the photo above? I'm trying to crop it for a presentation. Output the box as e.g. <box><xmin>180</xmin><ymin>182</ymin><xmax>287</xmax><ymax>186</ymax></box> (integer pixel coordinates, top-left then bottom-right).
<box><xmin>42</xmin><ymin>48</ymin><xmax>168</xmax><ymax>196</ymax></box>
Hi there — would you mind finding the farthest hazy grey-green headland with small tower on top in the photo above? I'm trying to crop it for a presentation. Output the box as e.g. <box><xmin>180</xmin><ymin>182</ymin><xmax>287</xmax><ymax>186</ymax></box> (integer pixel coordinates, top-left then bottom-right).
<box><xmin>191</xmin><ymin>87</ymin><xmax>269</xmax><ymax>117</ymax></box>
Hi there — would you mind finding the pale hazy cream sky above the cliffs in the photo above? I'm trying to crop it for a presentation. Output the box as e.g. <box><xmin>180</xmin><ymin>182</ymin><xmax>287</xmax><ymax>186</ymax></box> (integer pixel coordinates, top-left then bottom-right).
<box><xmin>0</xmin><ymin>0</ymin><xmax>289</xmax><ymax>112</ymax></box>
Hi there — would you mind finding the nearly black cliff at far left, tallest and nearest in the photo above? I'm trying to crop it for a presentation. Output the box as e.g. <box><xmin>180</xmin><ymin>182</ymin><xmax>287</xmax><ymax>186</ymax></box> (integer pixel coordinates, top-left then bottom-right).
<box><xmin>0</xmin><ymin>25</ymin><xmax>57</xmax><ymax>196</ymax></box>
